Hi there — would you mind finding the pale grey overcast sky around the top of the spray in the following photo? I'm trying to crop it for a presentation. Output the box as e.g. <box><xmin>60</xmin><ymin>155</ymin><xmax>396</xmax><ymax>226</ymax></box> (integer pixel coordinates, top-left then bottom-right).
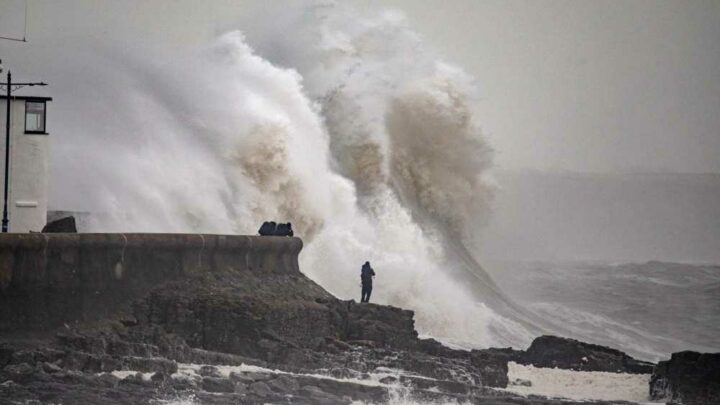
<box><xmin>0</xmin><ymin>0</ymin><xmax>720</xmax><ymax>173</ymax></box>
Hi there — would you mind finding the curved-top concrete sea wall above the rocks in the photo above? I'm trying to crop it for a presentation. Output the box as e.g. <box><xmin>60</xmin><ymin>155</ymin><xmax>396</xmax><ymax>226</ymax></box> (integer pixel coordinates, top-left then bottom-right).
<box><xmin>0</xmin><ymin>233</ymin><xmax>302</xmax><ymax>334</ymax></box>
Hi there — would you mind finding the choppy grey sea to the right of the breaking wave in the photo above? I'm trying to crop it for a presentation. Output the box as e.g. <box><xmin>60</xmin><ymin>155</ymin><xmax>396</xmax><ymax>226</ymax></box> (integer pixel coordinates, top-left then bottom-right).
<box><xmin>487</xmin><ymin>261</ymin><xmax>720</xmax><ymax>361</ymax></box>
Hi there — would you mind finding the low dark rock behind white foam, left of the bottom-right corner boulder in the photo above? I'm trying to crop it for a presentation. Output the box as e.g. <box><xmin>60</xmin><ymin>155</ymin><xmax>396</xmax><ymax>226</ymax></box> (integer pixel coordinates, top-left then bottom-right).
<box><xmin>520</xmin><ymin>336</ymin><xmax>654</xmax><ymax>374</ymax></box>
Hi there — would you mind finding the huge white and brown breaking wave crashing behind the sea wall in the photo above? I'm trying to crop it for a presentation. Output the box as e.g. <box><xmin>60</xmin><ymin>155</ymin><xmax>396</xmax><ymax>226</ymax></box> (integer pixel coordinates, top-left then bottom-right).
<box><xmin>56</xmin><ymin>6</ymin><xmax>533</xmax><ymax>346</ymax></box>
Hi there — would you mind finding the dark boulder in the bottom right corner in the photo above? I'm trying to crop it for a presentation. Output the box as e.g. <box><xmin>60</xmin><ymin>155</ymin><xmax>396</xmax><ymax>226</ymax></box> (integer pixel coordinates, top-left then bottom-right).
<box><xmin>650</xmin><ymin>351</ymin><xmax>720</xmax><ymax>405</ymax></box>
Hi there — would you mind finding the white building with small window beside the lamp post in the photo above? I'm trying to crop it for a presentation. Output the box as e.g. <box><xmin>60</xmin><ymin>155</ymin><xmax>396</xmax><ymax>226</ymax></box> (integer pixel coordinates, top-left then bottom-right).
<box><xmin>0</xmin><ymin>96</ymin><xmax>52</xmax><ymax>233</ymax></box>
